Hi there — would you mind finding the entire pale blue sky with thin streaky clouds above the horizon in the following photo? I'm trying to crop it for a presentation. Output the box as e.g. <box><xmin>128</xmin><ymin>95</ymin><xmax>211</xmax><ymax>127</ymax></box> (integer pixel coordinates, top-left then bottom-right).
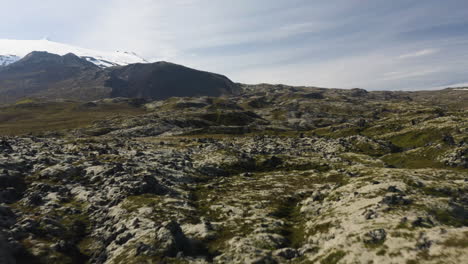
<box><xmin>0</xmin><ymin>0</ymin><xmax>468</xmax><ymax>90</ymax></box>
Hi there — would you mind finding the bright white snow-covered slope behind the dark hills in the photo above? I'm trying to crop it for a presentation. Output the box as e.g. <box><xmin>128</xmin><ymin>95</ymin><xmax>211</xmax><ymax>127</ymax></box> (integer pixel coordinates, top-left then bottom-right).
<box><xmin>0</xmin><ymin>39</ymin><xmax>148</xmax><ymax>68</ymax></box>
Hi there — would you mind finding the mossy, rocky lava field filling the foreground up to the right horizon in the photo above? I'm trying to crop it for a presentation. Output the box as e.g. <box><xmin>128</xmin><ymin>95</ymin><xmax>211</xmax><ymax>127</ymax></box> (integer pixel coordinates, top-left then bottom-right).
<box><xmin>0</xmin><ymin>85</ymin><xmax>468</xmax><ymax>264</ymax></box>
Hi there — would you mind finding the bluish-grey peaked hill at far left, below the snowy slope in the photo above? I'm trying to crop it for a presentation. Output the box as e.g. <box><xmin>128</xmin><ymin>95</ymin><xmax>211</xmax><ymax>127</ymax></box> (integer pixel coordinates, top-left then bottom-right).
<box><xmin>0</xmin><ymin>52</ymin><xmax>105</xmax><ymax>103</ymax></box>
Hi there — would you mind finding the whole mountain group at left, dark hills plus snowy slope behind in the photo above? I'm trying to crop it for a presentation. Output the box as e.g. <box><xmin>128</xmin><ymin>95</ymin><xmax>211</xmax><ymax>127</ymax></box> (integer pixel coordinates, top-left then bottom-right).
<box><xmin>0</xmin><ymin>40</ymin><xmax>240</xmax><ymax>104</ymax></box>
